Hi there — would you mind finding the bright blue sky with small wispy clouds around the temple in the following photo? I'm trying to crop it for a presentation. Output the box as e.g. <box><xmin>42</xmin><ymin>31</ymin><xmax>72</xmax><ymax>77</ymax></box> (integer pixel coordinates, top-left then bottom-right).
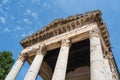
<box><xmin>0</xmin><ymin>0</ymin><xmax>120</xmax><ymax>80</ymax></box>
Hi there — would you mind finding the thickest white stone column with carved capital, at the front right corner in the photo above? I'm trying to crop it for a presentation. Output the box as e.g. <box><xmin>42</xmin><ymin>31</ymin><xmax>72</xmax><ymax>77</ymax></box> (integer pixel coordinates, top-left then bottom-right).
<box><xmin>89</xmin><ymin>29</ymin><xmax>106</xmax><ymax>80</ymax></box>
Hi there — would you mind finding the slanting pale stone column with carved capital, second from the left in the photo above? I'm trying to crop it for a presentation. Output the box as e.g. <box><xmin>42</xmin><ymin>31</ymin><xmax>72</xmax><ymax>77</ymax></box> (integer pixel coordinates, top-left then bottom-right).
<box><xmin>24</xmin><ymin>47</ymin><xmax>46</xmax><ymax>80</ymax></box>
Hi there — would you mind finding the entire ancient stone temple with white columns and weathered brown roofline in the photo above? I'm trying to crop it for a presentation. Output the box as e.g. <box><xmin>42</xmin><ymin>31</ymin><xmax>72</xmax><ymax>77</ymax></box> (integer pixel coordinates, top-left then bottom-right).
<box><xmin>5</xmin><ymin>10</ymin><xmax>119</xmax><ymax>80</ymax></box>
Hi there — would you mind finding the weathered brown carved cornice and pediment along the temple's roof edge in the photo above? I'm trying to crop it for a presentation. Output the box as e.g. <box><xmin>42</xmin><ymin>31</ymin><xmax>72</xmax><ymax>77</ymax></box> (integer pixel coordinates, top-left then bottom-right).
<box><xmin>20</xmin><ymin>10</ymin><xmax>110</xmax><ymax>48</ymax></box>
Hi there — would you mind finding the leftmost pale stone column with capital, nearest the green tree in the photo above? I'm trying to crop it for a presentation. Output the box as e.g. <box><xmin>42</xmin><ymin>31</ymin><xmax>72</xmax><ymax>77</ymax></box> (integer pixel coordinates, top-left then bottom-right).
<box><xmin>5</xmin><ymin>55</ymin><xmax>25</xmax><ymax>80</ymax></box>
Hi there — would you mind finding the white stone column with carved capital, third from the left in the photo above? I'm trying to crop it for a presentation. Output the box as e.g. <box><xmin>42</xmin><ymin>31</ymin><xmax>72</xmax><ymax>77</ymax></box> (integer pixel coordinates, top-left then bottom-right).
<box><xmin>52</xmin><ymin>39</ymin><xmax>70</xmax><ymax>80</ymax></box>
